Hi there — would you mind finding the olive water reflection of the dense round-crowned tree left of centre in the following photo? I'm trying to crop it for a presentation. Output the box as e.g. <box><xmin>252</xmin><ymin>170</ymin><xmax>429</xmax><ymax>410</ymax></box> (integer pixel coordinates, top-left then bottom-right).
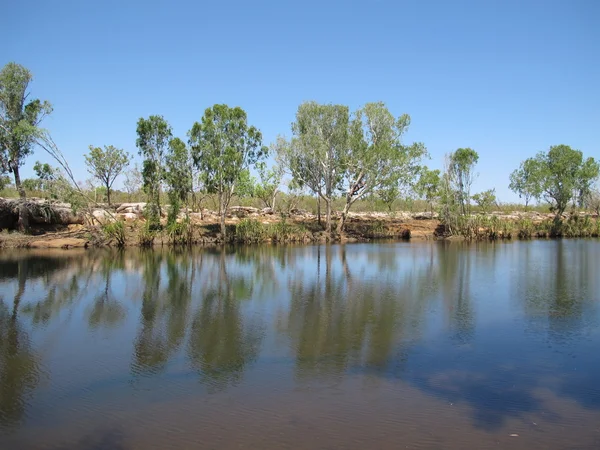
<box><xmin>188</xmin><ymin>252</ymin><xmax>263</xmax><ymax>390</ymax></box>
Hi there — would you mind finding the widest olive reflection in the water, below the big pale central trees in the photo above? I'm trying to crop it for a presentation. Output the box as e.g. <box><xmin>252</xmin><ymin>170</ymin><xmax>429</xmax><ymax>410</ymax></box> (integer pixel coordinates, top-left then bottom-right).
<box><xmin>284</xmin><ymin>246</ymin><xmax>431</xmax><ymax>380</ymax></box>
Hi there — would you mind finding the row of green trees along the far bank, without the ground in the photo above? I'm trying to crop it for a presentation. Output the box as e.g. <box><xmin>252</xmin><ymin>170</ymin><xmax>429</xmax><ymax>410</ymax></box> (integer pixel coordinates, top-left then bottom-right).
<box><xmin>0</xmin><ymin>63</ymin><xmax>600</xmax><ymax>237</ymax></box>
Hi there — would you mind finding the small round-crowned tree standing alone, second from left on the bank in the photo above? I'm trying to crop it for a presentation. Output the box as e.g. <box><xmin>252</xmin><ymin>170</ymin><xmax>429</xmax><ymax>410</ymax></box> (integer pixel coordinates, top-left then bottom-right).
<box><xmin>84</xmin><ymin>145</ymin><xmax>130</xmax><ymax>206</ymax></box>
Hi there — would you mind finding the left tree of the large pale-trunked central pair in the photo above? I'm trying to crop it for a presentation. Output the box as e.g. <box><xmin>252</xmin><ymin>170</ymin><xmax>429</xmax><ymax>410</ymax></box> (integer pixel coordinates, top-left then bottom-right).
<box><xmin>280</xmin><ymin>102</ymin><xmax>350</xmax><ymax>235</ymax></box>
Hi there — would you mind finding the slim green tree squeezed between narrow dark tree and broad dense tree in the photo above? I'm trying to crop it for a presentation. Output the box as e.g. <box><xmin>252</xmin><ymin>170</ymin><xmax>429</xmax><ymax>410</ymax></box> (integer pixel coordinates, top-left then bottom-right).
<box><xmin>165</xmin><ymin>138</ymin><xmax>192</xmax><ymax>222</ymax></box>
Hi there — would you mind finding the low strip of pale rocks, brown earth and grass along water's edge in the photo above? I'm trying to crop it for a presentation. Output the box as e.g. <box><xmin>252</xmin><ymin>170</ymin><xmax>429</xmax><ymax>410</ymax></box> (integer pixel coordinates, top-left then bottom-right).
<box><xmin>0</xmin><ymin>198</ymin><xmax>600</xmax><ymax>248</ymax></box>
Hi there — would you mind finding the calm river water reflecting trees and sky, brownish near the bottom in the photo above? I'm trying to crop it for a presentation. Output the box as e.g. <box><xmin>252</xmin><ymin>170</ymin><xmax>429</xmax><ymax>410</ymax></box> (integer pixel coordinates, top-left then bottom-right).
<box><xmin>0</xmin><ymin>240</ymin><xmax>600</xmax><ymax>450</ymax></box>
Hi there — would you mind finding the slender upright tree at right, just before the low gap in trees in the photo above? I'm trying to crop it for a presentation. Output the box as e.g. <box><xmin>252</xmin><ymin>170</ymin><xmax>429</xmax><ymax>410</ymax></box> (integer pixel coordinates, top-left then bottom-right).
<box><xmin>447</xmin><ymin>148</ymin><xmax>479</xmax><ymax>216</ymax></box>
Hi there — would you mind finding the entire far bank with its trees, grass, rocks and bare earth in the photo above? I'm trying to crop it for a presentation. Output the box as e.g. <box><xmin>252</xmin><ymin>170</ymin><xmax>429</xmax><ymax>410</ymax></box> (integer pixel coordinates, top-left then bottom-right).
<box><xmin>0</xmin><ymin>62</ymin><xmax>600</xmax><ymax>248</ymax></box>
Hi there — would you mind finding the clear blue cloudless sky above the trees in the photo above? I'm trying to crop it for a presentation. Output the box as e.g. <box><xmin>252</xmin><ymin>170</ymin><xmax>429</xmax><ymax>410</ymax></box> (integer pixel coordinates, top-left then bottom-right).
<box><xmin>0</xmin><ymin>0</ymin><xmax>600</xmax><ymax>201</ymax></box>
